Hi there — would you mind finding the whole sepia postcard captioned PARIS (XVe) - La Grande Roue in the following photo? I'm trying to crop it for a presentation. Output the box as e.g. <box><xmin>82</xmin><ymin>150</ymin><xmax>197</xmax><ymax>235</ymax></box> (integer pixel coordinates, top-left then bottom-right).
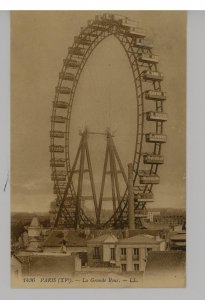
<box><xmin>10</xmin><ymin>10</ymin><xmax>186</xmax><ymax>288</ymax></box>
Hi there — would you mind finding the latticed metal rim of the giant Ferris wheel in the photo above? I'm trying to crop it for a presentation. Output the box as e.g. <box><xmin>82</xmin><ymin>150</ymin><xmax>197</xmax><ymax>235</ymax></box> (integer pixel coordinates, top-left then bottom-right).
<box><xmin>51</xmin><ymin>15</ymin><xmax>165</xmax><ymax>227</ymax></box>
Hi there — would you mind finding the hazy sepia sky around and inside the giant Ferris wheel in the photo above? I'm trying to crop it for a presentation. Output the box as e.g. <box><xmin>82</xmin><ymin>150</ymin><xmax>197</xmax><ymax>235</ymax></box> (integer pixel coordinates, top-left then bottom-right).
<box><xmin>11</xmin><ymin>11</ymin><xmax>186</xmax><ymax>212</ymax></box>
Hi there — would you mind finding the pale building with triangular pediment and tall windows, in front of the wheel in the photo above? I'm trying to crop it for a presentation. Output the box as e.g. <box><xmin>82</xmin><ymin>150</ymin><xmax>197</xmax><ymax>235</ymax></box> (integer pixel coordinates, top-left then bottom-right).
<box><xmin>87</xmin><ymin>234</ymin><xmax>165</xmax><ymax>272</ymax></box>
